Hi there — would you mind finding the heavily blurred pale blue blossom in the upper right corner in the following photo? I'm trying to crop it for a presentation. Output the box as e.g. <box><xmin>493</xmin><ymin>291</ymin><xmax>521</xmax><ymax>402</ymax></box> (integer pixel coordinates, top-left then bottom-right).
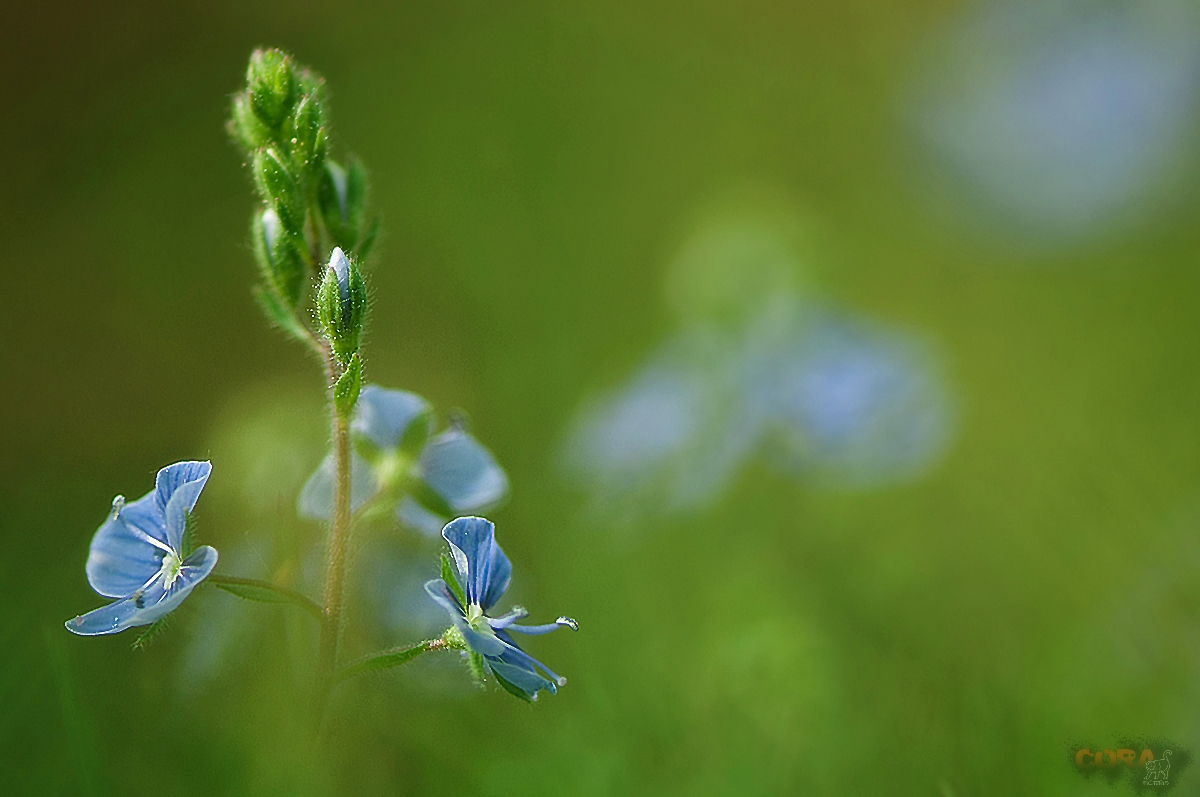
<box><xmin>908</xmin><ymin>0</ymin><xmax>1200</xmax><ymax>246</ymax></box>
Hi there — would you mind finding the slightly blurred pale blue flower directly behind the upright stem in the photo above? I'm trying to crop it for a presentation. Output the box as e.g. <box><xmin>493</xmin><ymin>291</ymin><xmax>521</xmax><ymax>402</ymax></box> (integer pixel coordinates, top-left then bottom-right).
<box><xmin>296</xmin><ymin>385</ymin><xmax>509</xmax><ymax>535</ymax></box>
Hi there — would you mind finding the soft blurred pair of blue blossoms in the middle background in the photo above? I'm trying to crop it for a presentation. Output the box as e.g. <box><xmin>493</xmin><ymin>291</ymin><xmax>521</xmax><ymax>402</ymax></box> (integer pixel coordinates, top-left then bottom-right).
<box><xmin>564</xmin><ymin>300</ymin><xmax>953</xmax><ymax>519</ymax></box>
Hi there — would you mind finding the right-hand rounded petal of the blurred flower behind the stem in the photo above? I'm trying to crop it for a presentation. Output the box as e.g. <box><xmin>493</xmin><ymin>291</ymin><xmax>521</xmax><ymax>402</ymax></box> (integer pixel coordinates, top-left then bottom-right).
<box><xmin>418</xmin><ymin>429</ymin><xmax>509</xmax><ymax>514</ymax></box>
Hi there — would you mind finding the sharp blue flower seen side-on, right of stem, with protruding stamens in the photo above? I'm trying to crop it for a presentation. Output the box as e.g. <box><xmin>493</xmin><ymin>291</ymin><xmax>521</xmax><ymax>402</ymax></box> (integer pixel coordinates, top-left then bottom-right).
<box><xmin>425</xmin><ymin>517</ymin><xmax>578</xmax><ymax>700</ymax></box>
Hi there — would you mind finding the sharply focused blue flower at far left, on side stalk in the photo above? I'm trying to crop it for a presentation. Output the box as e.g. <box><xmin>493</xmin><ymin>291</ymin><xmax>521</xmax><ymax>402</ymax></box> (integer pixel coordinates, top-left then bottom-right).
<box><xmin>66</xmin><ymin>462</ymin><xmax>217</xmax><ymax>636</ymax></box>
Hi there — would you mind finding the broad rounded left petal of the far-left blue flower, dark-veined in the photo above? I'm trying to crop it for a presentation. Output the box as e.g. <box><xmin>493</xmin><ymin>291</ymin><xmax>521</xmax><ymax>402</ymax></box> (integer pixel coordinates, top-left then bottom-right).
<box><xmin>86</xmin><ymin>492</ymin><xmax>166</xmax><ymax>598</ymax></box>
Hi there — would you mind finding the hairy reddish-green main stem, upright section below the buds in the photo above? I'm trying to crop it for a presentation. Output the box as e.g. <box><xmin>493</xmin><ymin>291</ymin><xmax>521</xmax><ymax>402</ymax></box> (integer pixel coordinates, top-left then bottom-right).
<box><xmin>317</xmin><ymin>376</ymin><xmax>350</xmax><ymax>707</ymax></box>
